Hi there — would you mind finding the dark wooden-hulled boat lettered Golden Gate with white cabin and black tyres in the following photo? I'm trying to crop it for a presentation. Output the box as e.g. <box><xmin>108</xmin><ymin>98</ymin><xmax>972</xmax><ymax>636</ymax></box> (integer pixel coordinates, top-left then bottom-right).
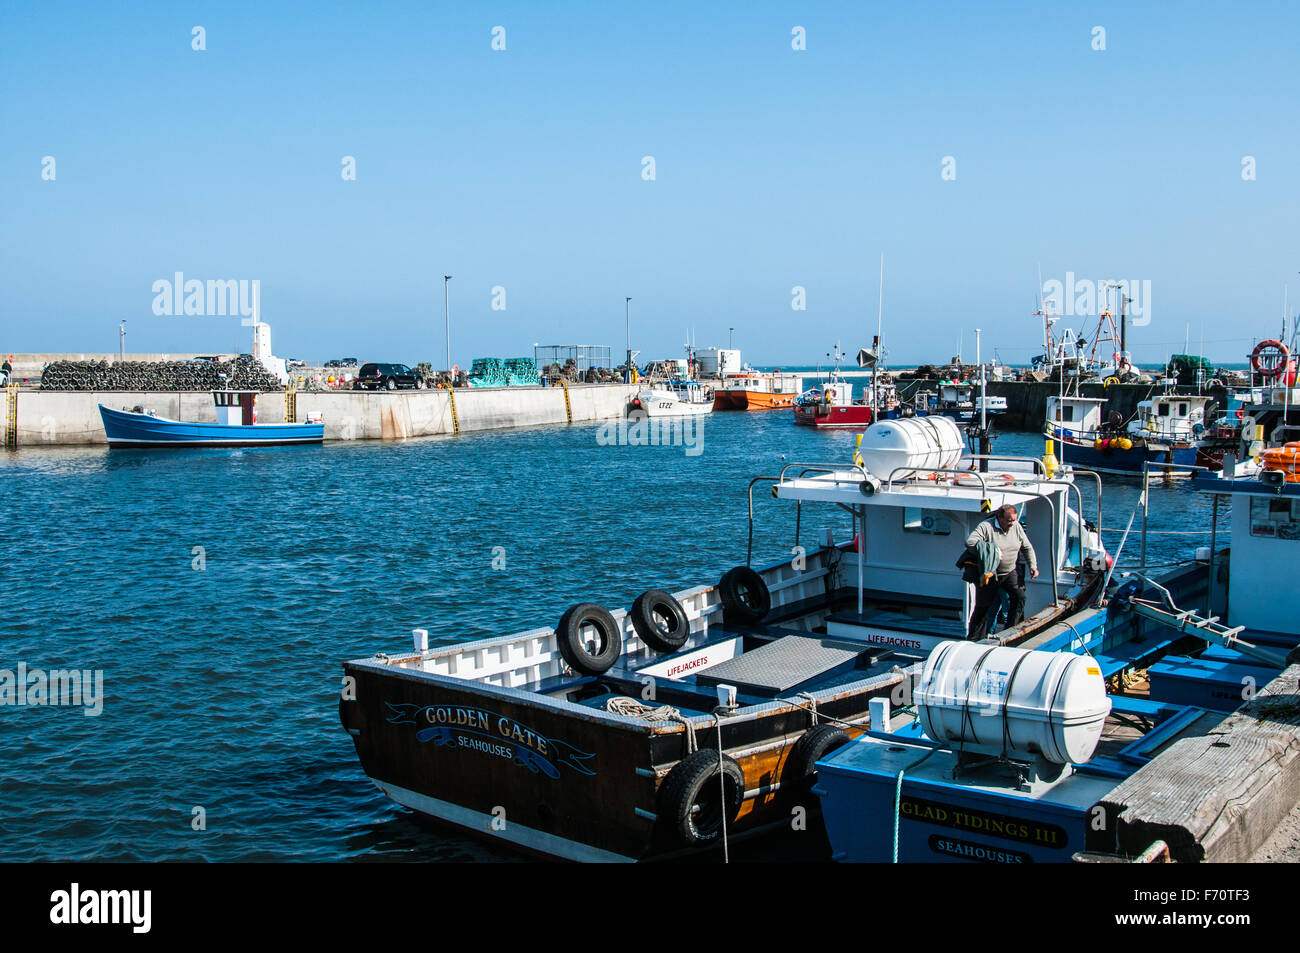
<box><xmin>339</xmin><ymin>419</ymin><xmax>1105</xmax><ymax>861</ymax></box>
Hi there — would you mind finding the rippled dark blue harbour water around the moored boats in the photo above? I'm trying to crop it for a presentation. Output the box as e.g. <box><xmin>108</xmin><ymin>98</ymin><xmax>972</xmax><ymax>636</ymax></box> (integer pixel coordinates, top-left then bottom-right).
<box><xmin>0</xmin><ymin>412</ymin><xmax>1208</xmax><ymax>861</ymax></box>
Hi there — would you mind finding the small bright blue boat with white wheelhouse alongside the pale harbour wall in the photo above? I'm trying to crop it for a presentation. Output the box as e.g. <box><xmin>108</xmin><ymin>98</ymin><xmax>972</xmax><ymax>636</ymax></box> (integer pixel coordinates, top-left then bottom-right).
<box><xmin>99</xmin><ymin>390</ymin><xmax>325</xmax><ymax>449</ymax></box>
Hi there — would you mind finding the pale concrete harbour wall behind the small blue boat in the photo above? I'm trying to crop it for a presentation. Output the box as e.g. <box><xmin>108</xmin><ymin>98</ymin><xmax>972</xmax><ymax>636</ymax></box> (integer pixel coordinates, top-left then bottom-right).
<box><xmin>5</xmin><ymin>384</ymin><xmax>638</xmax><ymax>447</ymax></box>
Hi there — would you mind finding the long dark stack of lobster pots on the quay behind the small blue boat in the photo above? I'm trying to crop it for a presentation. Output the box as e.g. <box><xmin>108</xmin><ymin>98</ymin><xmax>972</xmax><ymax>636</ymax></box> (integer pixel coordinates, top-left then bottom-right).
<box><xmin>40</xmin><ymin>355</ymin><xmax>283</xmax><ymax>391</ymax></box>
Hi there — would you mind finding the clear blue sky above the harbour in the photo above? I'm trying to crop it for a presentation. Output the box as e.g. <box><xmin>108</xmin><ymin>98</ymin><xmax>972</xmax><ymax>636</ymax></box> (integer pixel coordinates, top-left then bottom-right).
<box><xmin>0</xmin><ymin>1</ymin><xmax>1300</xmax><ymax>367</ymax></box>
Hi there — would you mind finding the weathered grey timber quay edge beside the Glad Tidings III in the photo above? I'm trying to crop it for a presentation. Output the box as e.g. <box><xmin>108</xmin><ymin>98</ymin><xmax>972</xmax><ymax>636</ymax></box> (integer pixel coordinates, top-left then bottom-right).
<box><xmin>1101</xmin><ymin>666</ymin><xmax>1300</xmax><ymax>863</ymax></box>
